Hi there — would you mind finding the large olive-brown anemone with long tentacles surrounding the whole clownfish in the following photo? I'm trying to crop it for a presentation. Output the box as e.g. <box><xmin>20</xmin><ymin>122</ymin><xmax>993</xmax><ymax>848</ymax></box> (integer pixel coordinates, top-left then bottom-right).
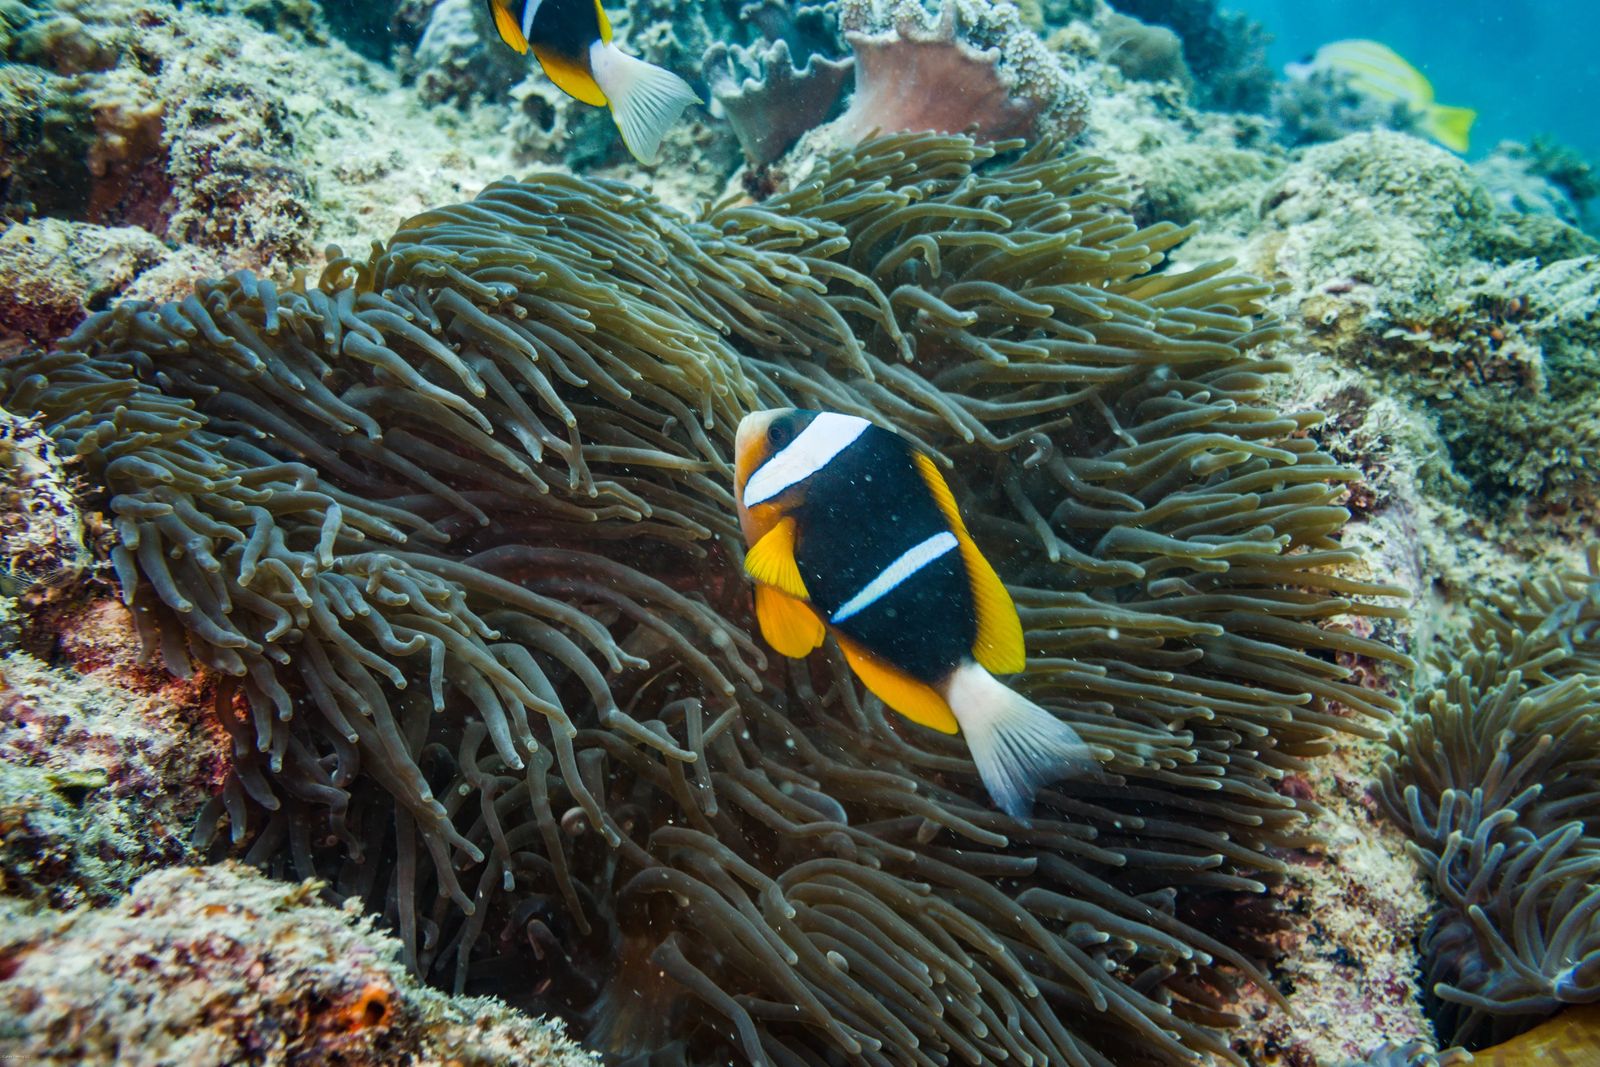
<box><xmin>3</xmin><ymin>134</ymin><xmax>1402</xmax><ymax>1067</ymax></box>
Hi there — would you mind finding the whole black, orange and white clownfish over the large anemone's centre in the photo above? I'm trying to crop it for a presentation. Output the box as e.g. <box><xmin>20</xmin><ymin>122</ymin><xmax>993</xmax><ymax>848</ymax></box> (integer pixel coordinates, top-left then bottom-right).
<box><xmin>734</xmin><ymin>408</ymin><xmax>1098</xmax><ymax>819</ymax></box>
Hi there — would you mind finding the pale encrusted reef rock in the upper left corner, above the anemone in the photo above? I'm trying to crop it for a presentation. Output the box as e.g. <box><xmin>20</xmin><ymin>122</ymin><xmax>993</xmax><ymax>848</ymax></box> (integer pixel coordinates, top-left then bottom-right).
<box><xmin>0</xmin><ymin>0</ymin><xmax>506</xmax><ymax>279</ymax></box>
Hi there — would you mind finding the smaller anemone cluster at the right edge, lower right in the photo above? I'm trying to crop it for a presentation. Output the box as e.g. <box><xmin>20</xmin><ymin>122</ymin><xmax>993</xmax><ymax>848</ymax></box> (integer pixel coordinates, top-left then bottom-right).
<box><xmin>1379</xmin><ymin>547</ymin><xmax>1600</xmax><ymax>1048</ymax></box>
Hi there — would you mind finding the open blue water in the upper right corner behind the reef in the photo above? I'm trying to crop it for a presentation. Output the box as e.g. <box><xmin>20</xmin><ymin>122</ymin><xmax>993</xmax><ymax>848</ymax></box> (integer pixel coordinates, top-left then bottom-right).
<box><xmin>1222</xmin><ymin>0</ymin><xmax>1600</xmax><ymax>158</ymax></box>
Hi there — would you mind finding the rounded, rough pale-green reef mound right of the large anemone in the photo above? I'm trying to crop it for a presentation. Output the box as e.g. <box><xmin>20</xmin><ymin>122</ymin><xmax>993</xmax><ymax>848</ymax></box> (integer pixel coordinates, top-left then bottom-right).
<box><xmin>1243</xmin><ymin>133</ymin><xmax>1600</xmax><ymax>517</ymax></box>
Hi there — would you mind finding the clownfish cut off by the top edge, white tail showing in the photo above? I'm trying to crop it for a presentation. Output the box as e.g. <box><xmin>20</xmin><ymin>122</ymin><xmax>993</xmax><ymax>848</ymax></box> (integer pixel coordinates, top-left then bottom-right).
<box><xmin>488</xmin><ymin>0</ymin><xmax>701</xmax><ymax>163</ymax></box>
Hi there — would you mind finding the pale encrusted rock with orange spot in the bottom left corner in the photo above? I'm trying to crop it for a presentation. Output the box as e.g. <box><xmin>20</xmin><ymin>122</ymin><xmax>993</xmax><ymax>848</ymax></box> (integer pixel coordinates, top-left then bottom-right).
<box><xmin>0</xmin><ymin>864</ymin><xmax>597</xmax><ymax>1067</ymax></box>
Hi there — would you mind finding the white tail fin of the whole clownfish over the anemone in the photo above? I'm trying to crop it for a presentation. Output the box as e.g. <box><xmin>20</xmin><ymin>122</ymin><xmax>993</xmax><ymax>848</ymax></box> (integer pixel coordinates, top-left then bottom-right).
<box><xmin>946</xmin><ymin>662</ymin><xmax>1099</xmax><ymax>819</ymax></box>
